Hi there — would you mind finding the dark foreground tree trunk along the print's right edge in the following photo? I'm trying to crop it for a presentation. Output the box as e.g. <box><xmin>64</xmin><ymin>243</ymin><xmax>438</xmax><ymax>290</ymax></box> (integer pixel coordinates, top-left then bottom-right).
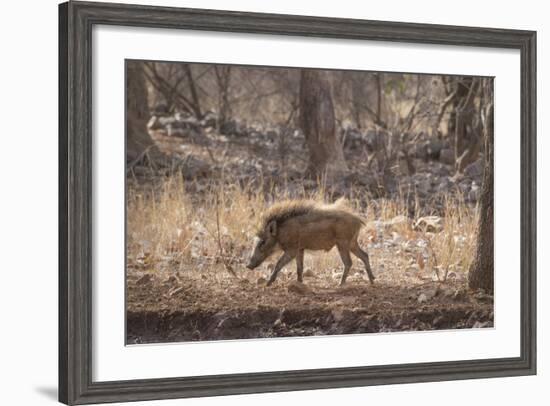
<box><xmin>468</xmin><ymin>79</ymin><xmax>494</xmax><ymax>293</ymax></box>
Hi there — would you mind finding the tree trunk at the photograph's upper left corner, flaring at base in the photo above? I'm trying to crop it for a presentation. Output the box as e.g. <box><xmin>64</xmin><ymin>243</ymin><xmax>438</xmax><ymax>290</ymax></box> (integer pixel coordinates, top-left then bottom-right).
<box><xmin>126</xmin><ymin>61</ymin><xmax>164</xmax><ymax>162</ymax></box>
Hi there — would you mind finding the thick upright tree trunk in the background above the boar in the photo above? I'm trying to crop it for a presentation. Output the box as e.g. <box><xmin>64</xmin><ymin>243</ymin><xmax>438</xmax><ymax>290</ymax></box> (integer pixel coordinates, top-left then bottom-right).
<box><xmin>299</xmin><ymin>69</ymin><xmax>347</xmax><ymax>179</ymax></box>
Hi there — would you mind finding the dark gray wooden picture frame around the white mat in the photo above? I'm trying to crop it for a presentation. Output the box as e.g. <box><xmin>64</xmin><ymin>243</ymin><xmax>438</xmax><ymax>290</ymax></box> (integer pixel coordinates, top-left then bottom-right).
<box><xmin>59</xmin><ymin>2</ymin><xmax>536</xmax><ymax>404</ymax></box>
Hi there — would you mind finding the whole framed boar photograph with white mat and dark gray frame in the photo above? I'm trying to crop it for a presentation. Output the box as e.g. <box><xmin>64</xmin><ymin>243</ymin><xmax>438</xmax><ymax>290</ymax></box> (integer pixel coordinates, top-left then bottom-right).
<box><xmin>59</xmin><ymin>2</ymin><xmax>536</xmax><ymax>404</ymax></box>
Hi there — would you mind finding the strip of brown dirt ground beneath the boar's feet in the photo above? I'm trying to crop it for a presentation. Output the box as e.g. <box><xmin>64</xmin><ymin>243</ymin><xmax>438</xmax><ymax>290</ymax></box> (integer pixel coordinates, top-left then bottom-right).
<box><xmin>127</xmin><ymin>271</ymin><xmax>493</xmax><ymax>344</ymax></box>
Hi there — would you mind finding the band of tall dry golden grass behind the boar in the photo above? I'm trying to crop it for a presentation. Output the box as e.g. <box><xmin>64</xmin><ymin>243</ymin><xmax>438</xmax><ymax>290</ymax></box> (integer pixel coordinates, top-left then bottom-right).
<box><xmin>127</xmin><ymin>175</ymin><xmax>478</xmax><ymax>283</ymax></box>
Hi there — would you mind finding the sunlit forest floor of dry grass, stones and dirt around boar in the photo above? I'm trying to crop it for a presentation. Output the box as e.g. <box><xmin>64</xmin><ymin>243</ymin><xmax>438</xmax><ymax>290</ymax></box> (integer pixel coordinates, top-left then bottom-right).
<box><xmin>127</xmin><ymin>119</ymin><xmax>493</xmax><ymax>344</ymax></box>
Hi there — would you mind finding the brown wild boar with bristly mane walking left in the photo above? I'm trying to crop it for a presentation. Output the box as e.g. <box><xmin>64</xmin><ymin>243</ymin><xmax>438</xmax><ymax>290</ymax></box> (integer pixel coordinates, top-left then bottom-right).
<box><xmin>247</xmin><ymin>199</ymin><xmax>375</xmax><ymax>286</ymax></box>
